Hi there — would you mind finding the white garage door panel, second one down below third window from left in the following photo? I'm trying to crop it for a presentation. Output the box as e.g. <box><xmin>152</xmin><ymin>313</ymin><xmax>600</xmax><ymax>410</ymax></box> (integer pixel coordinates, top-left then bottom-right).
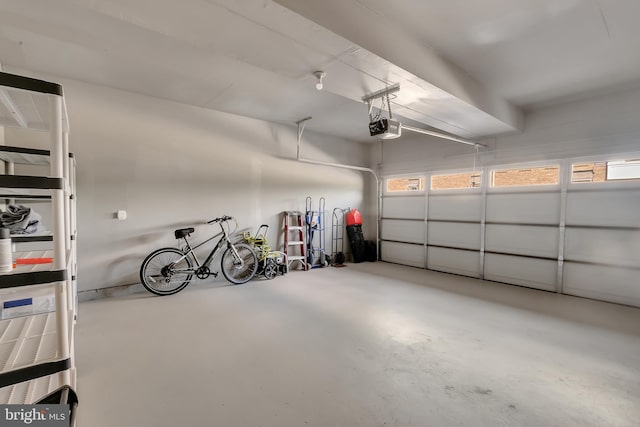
<box><xmin>485</xmin><ymin>224</ymin><xmax>559</xmax><ymax>258</ymax></box>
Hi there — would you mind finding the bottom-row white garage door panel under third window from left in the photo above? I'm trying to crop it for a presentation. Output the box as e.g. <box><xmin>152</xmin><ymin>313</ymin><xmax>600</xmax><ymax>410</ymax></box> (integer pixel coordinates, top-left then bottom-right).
<box><xmin>484</xmin><ymin>254</ymin><xmax>558</xmax><ymax>291</ymax></box>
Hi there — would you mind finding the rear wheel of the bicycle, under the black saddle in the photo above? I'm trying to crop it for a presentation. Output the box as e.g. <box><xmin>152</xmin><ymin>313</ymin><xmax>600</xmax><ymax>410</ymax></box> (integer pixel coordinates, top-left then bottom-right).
<box><xmin>140</xmin><ymin>248</ymin><xmax>193</xmax><ymax>295</ymax></box>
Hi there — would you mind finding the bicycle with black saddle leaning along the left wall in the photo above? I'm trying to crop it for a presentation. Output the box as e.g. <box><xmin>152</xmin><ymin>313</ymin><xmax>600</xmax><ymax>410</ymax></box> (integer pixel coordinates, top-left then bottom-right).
<box><xmin>140</xmin><ymin>215</ymin><xmax>258</xmax><ymax>296</ymax></box>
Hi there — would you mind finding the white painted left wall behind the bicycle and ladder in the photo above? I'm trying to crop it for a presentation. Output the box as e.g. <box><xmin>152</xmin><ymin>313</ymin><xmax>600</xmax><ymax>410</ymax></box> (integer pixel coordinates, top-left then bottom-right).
<box><xmin>6</xmin><ymin>70</ymin><xmax>370</xmax><ymax>291</ymax></box>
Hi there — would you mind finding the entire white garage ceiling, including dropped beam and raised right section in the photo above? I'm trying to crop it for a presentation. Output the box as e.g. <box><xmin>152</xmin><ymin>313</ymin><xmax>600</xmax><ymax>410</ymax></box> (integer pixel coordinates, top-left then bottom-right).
<box><xmin>0</xmin><ymin>0</ymin><xmax>640</xmax><ymax>141</ymax></box>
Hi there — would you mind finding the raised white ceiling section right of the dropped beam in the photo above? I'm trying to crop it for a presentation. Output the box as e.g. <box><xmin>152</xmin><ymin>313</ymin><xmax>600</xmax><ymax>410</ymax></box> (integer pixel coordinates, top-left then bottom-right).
<box><xmin>344</xmin><ymin>0</ymin><xmax>640</xmax><ymax>106</ymax></box>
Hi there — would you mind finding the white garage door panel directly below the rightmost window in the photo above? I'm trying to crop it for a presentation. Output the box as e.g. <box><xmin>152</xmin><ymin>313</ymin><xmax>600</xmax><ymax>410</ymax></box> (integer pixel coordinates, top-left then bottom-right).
<box><xmin>567</xmin><ymin>190</ymin><xmax>640</xmax><ymax>227</ymax></box>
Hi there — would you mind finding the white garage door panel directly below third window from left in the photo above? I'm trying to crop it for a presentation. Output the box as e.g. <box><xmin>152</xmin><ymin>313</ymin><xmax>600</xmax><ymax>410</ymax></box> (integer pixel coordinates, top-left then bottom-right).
<box><xmin>486</xmin><ymin>192</ymin><xmax>560</xmax><ymax>225</ymax></box>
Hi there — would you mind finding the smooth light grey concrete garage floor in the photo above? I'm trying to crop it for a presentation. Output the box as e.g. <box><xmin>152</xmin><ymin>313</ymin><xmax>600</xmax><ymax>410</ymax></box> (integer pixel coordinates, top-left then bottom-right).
<box><xmin>76</xmin><ymin>262</ymin><xmax>640</xmax><ymax>427</ymax></box>
